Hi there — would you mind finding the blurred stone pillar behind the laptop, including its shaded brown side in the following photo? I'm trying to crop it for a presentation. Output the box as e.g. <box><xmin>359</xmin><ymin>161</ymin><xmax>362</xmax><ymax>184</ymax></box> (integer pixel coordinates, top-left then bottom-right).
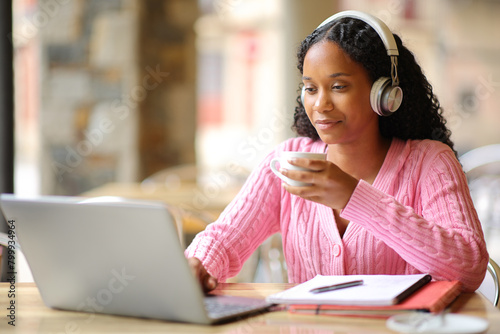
<box><xmin>13</xmin><ymin>0</ymin><xmax>198</xmax><ymax>195</ymax></box>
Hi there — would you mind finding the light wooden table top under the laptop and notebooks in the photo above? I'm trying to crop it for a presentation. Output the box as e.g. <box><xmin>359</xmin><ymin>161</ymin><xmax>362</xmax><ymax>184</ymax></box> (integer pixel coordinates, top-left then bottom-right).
<box><xmin>0</xmin><ymin>283</ymin><xmax>500</xmax><ymax>334</ymax></box>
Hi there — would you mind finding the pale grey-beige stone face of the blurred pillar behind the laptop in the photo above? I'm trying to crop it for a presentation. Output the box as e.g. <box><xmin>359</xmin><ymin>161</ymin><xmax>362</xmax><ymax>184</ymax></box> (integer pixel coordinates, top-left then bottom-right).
<box><xmin>27</xmin><ymin>0</ymin><xmax>143</xmax><ymax>195</ymax></box>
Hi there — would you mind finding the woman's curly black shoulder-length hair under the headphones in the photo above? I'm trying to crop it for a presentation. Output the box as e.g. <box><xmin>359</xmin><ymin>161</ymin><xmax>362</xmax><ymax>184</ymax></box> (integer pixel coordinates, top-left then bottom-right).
<box><xmin>292</xmin><ymin>18</ymin><xmax>456</xmax><ymax>154</ymax></box>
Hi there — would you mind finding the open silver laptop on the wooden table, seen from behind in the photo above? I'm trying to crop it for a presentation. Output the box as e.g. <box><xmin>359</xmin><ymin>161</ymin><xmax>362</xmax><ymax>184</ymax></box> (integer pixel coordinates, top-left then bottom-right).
<box><xmin>0</xmin><ymin>194</ymin><xmax>270</xmax><ymax>324</ymax></box>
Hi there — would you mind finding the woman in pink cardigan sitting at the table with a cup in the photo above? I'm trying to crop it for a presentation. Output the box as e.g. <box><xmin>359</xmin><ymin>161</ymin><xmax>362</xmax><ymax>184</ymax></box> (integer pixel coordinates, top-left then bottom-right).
<box><xmin>186</xmin><ymin>11</ymin><xmax>488</xmax><ymax>291</ymax></box>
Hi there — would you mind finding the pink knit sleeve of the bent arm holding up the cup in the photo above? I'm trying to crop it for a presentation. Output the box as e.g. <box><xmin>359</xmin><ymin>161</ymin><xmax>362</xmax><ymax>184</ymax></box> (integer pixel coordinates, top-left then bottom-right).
<box><xmin>341</xmin><ymin>150</ymin><xmax>488</xmax><ymax>291</ymax></box>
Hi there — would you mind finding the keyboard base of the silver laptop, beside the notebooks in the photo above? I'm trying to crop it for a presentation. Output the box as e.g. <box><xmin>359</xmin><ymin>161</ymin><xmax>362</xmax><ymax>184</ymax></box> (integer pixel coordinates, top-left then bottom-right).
<box><xmin>205</xmin><ymin>296</ymin><xmax>270</xmax><ymax>319</ymax></box>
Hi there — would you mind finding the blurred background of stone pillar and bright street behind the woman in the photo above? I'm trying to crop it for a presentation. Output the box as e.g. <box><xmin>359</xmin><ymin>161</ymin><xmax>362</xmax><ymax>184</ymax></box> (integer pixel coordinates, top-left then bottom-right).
<box><xmin>2</xmin><ymin>0</ymin><xmax>500</xmax><ymax>282</ymax></box>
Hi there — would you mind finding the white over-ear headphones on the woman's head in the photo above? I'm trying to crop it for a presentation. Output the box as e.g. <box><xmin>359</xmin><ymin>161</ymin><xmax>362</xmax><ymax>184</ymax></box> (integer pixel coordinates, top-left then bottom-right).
<box><xmin>300</xmin><ymin>10</ymin><xmax>403</xmax><ymax>116</ymax></box>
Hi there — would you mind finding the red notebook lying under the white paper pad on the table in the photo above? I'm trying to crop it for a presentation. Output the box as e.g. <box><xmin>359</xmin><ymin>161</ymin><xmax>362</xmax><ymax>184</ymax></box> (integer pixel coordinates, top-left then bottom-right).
<box><xmin>288</xmin><ymin>281</ymin><xmax>461</xmax><ymax>318</ymax></box>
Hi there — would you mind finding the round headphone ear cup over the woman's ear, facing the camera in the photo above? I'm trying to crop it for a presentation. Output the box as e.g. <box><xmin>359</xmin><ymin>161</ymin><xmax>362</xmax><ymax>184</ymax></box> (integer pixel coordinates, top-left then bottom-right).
<box><xmin>370</xmin><ymin>77</ymin><xmax>403</xmax><ymax>116</ymax></box>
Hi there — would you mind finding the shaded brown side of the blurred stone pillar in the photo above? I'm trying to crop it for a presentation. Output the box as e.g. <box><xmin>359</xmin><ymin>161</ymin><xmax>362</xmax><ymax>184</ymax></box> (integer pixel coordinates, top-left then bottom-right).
<box><xmin>136</xmin><ymin>0</ymin><xmax>199</xmax><ymax>180</ymax></box>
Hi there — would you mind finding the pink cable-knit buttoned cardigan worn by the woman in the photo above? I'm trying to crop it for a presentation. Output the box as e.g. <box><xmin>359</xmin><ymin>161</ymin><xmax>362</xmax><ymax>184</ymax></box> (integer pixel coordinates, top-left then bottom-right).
<box><xmin>185</xmin><ymin>138</ymin><xmax>488</xmax><ymax>291</ymax></box>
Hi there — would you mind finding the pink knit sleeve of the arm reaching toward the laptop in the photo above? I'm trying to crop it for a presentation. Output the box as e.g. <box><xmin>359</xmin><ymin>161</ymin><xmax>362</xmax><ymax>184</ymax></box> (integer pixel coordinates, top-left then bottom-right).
<box><xmin>185</xmin><ymin>147</ymin><xmax>281</xmax><ymax>282</ymax></box>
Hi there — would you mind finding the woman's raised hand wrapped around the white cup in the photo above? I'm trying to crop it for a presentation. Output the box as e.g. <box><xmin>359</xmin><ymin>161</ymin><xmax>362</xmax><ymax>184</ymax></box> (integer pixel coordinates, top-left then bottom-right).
<box><xmin>280</xmin><ymin>158</ymin><xmax>358</xmax><ymax>210</ymax></box>
